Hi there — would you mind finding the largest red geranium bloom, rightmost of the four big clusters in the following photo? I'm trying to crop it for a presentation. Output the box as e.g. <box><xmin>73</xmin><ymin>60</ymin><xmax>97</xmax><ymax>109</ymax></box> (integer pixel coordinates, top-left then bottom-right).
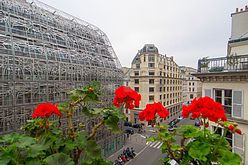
<box><xmin>182</xmin><ymin>96</ymin><xmax>227</xmax><ymax>122</ymax></box>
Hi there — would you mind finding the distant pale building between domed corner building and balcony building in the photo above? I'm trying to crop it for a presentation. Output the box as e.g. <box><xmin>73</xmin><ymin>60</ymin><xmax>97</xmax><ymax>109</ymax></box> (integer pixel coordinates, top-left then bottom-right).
<box><xmin>180</xmin><ymin>66</ymin><xmax>202</xmax><ymax>105</ymax></box>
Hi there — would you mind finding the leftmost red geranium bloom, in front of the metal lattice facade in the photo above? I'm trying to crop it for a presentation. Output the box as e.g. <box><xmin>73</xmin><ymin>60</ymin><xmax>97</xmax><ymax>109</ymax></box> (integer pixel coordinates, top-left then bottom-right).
<box><xmin>32</xmin><ymin>103</ymin><xmax>61</xmax><ymax>118</ymax></box>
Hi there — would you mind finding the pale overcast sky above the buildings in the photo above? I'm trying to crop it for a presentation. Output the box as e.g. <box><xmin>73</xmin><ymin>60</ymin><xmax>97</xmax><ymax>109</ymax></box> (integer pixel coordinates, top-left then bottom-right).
<box><xmin>40</xmin><ymin>0</ymin><xmax>248</xmax><ymax>68</ymax></box>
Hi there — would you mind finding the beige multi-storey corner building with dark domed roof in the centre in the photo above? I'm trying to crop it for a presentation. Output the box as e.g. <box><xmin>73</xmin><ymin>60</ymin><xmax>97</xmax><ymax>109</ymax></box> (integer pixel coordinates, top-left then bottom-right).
<box><xmin>123</xmin><ymin>44</ymin><xmax>183</xmax><ymax>125</ymax></box>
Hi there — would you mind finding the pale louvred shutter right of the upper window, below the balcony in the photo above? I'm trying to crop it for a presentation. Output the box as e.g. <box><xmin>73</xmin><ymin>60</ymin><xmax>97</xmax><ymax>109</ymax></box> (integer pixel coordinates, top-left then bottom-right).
<box><xmin>232</xmin><ymin>90</ymin><xmax>243</xmax><ymax>118</ymax></box>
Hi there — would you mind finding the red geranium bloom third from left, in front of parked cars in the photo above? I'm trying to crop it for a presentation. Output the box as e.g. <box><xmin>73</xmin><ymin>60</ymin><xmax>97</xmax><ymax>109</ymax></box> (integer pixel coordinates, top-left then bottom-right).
<box><xmin>139</xmin><ymin>102</ymin><xmax>169</xmax><ymax>121</ymax></box>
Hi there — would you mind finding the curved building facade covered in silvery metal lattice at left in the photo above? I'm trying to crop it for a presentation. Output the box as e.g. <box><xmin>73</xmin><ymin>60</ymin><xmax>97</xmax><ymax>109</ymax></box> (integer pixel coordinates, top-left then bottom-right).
<box><xmin>0</xmin><ymin>0</ymin><xmax>123</xmax><ymax>157</ymax></box>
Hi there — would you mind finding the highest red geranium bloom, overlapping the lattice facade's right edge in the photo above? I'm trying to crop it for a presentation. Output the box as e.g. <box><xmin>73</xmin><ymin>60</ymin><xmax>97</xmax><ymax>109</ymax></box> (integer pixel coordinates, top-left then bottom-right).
<box><xmin>113</xmin><ymin>86</ymin><xmax>141</xmax><ymax>109</ymax></box>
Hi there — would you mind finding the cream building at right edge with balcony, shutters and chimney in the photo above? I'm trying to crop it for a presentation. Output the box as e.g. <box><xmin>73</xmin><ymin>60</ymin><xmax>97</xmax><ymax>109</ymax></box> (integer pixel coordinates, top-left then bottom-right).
<box><xmin>195</xmin><ymin>6</ymin><xmax>248</xmax><ymax>165</ymax></box>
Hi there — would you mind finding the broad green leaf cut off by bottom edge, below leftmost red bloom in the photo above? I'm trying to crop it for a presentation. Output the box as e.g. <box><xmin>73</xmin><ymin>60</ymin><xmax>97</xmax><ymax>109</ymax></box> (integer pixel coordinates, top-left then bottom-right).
<box><xmin>44</xmin><ymin>153</ymin><xmax>75</xmax><ymax>165</ymax></box>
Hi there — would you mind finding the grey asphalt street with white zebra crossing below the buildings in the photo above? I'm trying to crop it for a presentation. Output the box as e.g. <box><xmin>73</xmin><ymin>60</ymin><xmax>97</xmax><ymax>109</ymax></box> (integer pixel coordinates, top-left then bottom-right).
<box><xmin>107</xmin><ymin>119</ymin><xmax>198</xmax><ymax>165</ymax></box>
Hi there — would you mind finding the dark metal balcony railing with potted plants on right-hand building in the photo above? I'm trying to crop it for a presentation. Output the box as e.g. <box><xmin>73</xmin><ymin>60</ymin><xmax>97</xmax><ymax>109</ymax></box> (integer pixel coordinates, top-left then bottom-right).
<box><xmin>198</xmin><ymin>55</ymin><xmax>248</xmax><ymax>73</ymax></box>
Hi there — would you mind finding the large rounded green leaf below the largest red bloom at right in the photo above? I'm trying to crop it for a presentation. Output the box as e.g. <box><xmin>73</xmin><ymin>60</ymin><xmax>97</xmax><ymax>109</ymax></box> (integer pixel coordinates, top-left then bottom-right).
<box><xmin>189</xmin><ymin>141</ymin><xmax>210</xmax><ymax>161</ymax></box>
